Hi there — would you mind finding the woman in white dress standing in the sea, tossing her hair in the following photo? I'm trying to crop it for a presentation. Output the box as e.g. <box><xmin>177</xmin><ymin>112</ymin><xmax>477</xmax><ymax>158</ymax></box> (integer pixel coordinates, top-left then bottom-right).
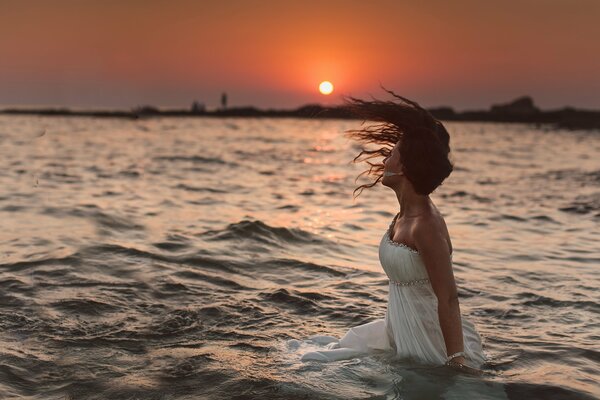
<box><xmin>302</xmin><ymin>88</ymin><xmax>485</xmax><ymax>374</ymax></box>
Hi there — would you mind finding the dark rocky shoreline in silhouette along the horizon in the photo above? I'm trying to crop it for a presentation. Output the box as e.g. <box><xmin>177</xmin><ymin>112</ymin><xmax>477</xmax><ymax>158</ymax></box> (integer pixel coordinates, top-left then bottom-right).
<box><xmin>0</xmin><ymin>96</ymin><xmax>600</xmax><ymax>130</ymax></box>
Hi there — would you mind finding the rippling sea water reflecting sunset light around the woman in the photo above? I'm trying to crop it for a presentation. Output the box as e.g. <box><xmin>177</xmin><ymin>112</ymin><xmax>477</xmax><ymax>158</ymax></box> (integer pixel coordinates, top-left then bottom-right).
<box><xmin>0</xmin><ymin>116</ymin><xmax>600</xmax><ymax>399</ymax></box>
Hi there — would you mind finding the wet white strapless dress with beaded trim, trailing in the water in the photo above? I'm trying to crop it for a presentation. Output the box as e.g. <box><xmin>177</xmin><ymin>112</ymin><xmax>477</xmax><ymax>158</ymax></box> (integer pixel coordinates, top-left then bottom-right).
<box><xmin>301</xmin><ymin>212</ymin><xmax>486</xmax><ymax>368</ymax></box>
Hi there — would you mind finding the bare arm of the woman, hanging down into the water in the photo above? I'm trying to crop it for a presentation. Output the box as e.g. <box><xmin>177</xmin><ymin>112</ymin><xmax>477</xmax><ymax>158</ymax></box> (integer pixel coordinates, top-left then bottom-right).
<box><xmin>412</xmin><ymin>219</ymin><xmax>464</xmax><ymax>363</ymax></box>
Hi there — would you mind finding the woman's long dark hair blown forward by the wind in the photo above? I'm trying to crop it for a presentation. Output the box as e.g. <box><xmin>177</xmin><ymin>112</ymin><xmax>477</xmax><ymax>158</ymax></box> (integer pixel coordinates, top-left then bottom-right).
<box><xmin>343</xmin><ymin>85</ymin><xmax>453</xmax><ymax>198</ymax></box>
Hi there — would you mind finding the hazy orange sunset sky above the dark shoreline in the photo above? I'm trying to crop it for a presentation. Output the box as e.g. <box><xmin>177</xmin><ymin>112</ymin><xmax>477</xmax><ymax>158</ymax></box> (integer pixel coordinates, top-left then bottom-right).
<box><xmin>0</xmin><ymin>0</ymin><xmax>600</xmax><ymax>110</ymax></box>
